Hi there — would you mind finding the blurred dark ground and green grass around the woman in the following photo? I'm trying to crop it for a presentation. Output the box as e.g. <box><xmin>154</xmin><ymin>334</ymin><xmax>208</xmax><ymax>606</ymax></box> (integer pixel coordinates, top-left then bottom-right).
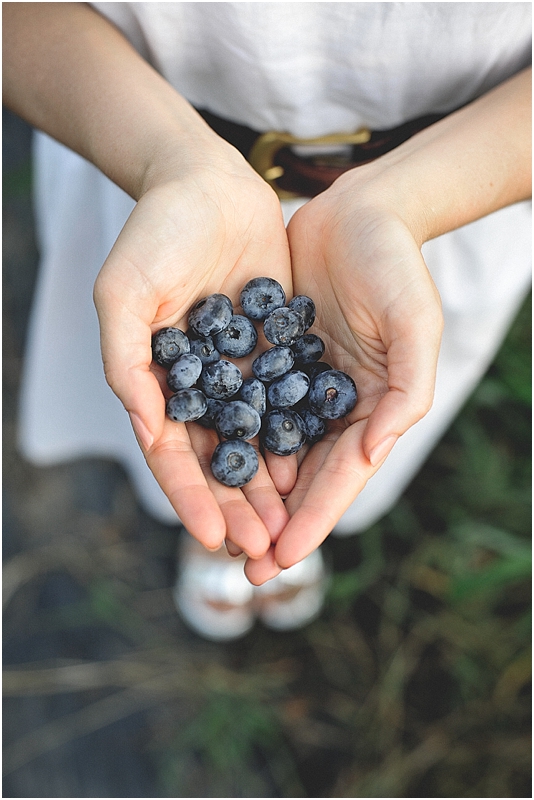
<box><xmin>3</xmin><ymin>113</ymin><xmax>532</xmax><ymax>797</ymax></box>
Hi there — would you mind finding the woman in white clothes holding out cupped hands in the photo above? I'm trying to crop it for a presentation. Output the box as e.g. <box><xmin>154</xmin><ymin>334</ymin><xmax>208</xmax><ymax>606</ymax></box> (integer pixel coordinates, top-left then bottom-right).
<box><xmin>4</xmin><ymin>3</ymin><xmax>531</xmax><ymax>627</ymax></box>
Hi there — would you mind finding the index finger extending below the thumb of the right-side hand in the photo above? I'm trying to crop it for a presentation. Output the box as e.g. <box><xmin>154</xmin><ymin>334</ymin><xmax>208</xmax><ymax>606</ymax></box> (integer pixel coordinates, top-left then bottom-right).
<box><xmin>275</xmin><ymin>420</ymin><xmax>376</xmax><ymax>569</ymax></box>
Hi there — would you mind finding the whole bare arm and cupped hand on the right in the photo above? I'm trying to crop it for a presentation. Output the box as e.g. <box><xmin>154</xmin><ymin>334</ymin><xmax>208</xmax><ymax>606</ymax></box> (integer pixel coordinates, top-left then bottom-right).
<box><xmin>246</xmin><ymin>68</ymin><xmax>532</xmax><ymax>583</ymax></box>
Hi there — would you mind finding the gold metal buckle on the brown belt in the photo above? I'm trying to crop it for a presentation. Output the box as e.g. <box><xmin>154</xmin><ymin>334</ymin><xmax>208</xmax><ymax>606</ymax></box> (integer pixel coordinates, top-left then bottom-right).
<box><xmin>248</xmin><ymin>128</ymin><xmax>371</xmax><ymax>200</ymax></box>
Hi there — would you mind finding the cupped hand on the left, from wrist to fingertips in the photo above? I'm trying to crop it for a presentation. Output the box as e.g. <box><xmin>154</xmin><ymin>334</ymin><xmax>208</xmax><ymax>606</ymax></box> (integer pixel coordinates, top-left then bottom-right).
<box><xmin>94</xmin><ymin>142</ymin><xmax>296</xmax><ymax>558</ymax></box>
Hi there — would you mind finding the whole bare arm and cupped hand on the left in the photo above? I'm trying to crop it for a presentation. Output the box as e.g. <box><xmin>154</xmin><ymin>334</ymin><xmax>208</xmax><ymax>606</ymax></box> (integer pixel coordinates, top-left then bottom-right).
<box><xmin>2</xmin><ymin>3</ymin><xmax>296</xmax><ymax>558</ymax></box>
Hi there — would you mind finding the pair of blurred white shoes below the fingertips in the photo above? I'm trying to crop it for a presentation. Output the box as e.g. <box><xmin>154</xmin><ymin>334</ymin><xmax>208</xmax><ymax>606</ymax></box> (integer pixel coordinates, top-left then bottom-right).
<box><xmin>173</xmin><ymin>534</ymin><xmax>328</xmax><ymax>642</ymax></box>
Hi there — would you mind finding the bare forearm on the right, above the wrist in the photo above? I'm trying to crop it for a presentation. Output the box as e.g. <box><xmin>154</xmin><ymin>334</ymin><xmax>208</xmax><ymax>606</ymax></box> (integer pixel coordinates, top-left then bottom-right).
<box><xmin>339</xmin><ymin>69</ymin><xmax>532</xmax><ymax>243</ymax></box>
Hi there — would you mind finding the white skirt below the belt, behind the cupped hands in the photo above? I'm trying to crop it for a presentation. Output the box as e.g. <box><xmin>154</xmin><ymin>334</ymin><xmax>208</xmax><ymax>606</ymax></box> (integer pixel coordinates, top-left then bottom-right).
<box><xmin>19</xmin><ymin>133</ymin><xmax>531</xmax><ymax>535</ymax></box>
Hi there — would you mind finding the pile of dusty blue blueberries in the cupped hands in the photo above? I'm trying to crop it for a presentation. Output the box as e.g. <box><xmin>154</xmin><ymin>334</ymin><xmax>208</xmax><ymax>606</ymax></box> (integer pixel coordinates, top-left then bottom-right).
<box><xmin>152</xmin><ymin>278</ymin><xmax>357</xmax><ymax>486</ymax></box>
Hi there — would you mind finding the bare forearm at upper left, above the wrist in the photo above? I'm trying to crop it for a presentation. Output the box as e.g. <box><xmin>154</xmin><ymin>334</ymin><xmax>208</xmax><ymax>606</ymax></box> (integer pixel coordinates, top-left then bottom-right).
<box><xmin>3</xmin><ymin>3</ymin><xmax>224</xmax><ymax>199</ymax></box>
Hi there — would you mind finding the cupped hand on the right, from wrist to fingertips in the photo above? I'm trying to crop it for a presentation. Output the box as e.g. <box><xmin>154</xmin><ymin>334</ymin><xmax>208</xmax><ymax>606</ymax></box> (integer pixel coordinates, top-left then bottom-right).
<box><xmin>246</xmin><ymin>168</ymin><xmax>442</xmax><ymax>583</ymax></box>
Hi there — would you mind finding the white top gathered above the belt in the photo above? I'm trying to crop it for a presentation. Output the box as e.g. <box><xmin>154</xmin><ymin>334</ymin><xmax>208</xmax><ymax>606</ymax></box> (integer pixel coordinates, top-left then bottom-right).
<box><xmin>93</xmin><ymin>2</ymin><xmax>531</xmax><ymax>137</ymax></box>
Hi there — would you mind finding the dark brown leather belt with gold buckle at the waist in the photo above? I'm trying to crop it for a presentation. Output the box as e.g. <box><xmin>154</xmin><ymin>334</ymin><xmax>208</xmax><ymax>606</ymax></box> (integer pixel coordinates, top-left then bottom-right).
<box><xmin>197</xmin><ymin>109</ymin><xmax>445</xmax><ymax>200</ymax></box>
